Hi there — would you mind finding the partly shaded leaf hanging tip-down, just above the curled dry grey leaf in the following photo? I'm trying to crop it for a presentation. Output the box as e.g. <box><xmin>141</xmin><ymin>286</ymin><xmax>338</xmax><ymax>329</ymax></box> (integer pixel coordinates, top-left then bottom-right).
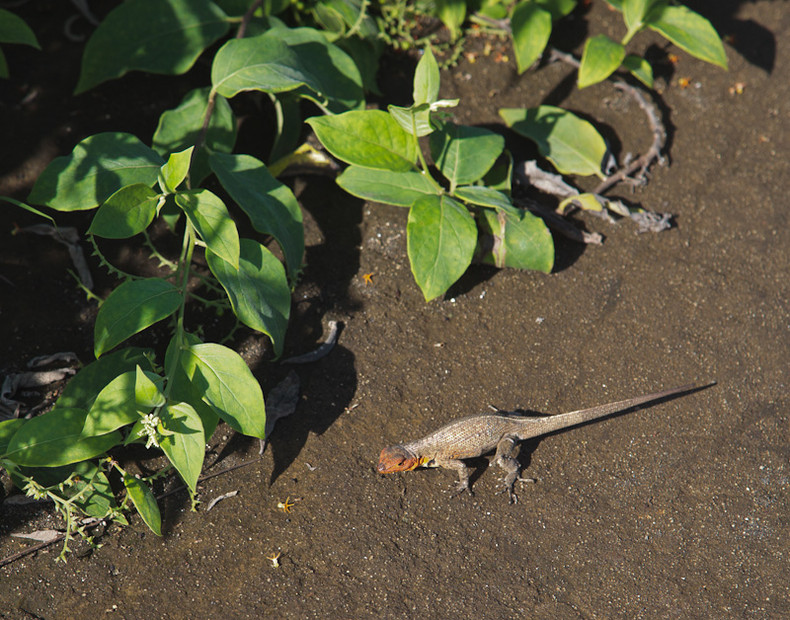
<box><xmin>206</xmin><ymin>239</ymin><xmax>291</xmax><ymax>357</ymax></box>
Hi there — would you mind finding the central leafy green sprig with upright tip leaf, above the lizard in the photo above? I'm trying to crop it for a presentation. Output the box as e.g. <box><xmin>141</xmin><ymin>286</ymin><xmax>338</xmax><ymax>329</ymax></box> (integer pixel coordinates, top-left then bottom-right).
<box><xmin>307</xmin><ymin>48</ymin><xmax>554</xmax><ymax>300</ymax></box>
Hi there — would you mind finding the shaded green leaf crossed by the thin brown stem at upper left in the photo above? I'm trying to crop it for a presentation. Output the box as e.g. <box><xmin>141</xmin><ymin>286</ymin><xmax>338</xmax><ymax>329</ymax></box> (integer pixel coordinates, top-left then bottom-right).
<box><xmin>152</xmin><ymin>88</ymin><xmax>236</xmax><ymax>187</ymax></box>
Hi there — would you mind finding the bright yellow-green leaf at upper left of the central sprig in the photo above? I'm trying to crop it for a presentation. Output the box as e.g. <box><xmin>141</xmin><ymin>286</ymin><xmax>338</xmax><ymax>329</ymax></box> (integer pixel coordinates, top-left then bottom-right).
<box><xmin>307</xmin><ymin>110</ymin><xmax>417</xmax><ymax>172</ymax></box>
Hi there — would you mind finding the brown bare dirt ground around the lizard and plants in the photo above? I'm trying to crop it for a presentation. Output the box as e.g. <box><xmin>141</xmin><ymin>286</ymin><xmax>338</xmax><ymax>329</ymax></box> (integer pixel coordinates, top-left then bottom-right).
<box><xmin>0</xmin><ymin>1</ymin><xmax>790</xmax><ymax>619</ymax></box>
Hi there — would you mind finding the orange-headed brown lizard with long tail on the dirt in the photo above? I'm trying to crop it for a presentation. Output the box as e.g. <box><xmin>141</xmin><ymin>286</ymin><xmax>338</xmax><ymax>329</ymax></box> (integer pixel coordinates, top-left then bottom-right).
<box><xmin>377</xmin><ymin>382</ymin><xmax>715</xmax><ymax>504</ymax></box>
